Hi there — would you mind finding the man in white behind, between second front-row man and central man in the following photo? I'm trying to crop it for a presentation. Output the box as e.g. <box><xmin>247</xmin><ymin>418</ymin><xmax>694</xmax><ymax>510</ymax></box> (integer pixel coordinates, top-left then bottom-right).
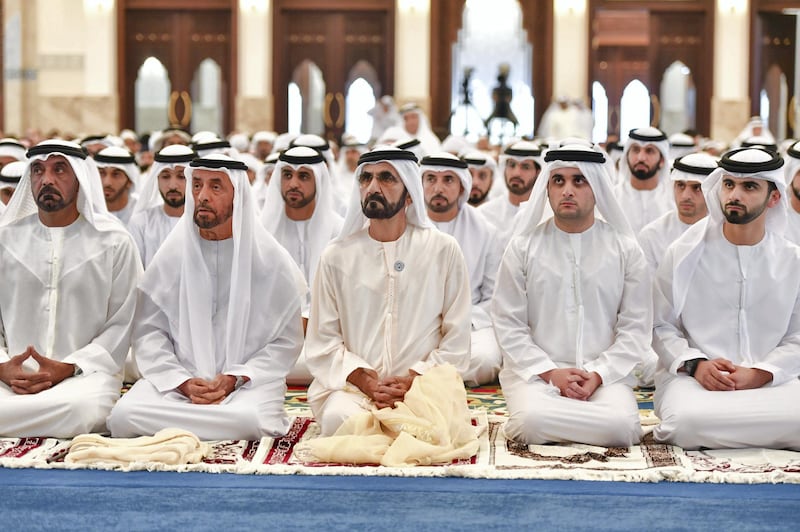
<box><xmin>261</xmin><ymin>146</ymin><xmax>342</xmax><ymax>384</ymax></box>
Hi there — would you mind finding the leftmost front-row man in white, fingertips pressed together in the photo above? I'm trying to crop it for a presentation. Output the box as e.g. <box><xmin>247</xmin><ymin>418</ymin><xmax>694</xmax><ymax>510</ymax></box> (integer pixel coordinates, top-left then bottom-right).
<box><xmin>0</xmin><ymin>141</ymin><xmax>142</xmax><ymax>438</ymax></box>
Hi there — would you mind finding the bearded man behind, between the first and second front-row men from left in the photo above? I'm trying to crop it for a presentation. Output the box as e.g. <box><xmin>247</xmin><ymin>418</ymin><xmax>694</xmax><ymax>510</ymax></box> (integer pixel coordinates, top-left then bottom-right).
<box><xmin>128</xmin><ymin>144</ymin><xmax>196</xmax><ymax>268</ymax></box>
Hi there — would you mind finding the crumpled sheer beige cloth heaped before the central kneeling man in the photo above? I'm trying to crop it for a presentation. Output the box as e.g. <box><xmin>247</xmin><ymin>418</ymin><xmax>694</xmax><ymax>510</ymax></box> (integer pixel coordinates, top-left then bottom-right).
<box><xmin>296</xmin><ymin>365</ymin><xmax>478</xmax><ymax>467</ymax></box>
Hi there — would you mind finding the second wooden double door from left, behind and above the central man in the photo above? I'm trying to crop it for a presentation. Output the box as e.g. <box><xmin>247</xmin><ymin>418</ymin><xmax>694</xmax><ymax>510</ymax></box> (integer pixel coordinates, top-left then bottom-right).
<box><xmin>273</xmin><ymin>0</ymin><xmax>394</xmax><ymax>141</ymax></box>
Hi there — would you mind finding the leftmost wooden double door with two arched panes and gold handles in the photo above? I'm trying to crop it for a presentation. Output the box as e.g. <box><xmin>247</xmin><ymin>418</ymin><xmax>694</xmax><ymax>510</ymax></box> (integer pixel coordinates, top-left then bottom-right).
<box><xmin>120</xmin><ymin>5</ymin><xmax>235</xmax><ymax>135</ymax></box>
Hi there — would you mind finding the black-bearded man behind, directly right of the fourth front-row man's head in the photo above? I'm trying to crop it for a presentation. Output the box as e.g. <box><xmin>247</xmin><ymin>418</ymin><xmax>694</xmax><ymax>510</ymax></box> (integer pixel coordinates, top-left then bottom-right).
<box><xmin>615</xmin><ymin>127</ymin><xmax>674</xmax><ymax>234</ymax></box>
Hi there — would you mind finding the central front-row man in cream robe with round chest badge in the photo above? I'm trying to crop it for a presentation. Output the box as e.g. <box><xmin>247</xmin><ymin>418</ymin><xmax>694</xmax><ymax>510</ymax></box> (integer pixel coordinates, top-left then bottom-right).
<box><xmin>306</xmin><ymin>147</ymin><xmax>471</xmax><ymax>435</ymax></box>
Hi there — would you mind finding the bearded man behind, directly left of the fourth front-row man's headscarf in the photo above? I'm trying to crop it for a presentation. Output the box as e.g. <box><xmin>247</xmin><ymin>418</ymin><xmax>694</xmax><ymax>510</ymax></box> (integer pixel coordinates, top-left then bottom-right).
<box><xmin>480</xmin><ymin>140</ymin><xmax>542</xmax><ymax>244</ymax></box>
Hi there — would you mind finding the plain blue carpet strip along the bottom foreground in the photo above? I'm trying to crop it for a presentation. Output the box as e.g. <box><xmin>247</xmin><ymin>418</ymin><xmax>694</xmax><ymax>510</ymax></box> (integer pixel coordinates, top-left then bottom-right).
<box><xmin>0</xmin><ymin>469</ymin><xmax>800</xmax><ymax>531</ymax></box>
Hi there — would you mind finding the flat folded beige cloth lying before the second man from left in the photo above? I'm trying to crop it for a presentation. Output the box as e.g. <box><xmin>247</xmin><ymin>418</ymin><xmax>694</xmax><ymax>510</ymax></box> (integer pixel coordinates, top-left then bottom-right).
<box><xmin>64</xmin><ymin>428</ymin><xmax>209</xmax><ymax>466</ymax></box>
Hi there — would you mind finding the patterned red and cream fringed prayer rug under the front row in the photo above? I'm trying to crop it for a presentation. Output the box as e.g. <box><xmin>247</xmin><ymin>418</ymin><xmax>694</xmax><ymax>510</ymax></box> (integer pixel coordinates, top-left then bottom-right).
<box><xmin>0</xmin><ymin>412</ymin><xmax>800</xmax><ymax>484</ymax></box>
